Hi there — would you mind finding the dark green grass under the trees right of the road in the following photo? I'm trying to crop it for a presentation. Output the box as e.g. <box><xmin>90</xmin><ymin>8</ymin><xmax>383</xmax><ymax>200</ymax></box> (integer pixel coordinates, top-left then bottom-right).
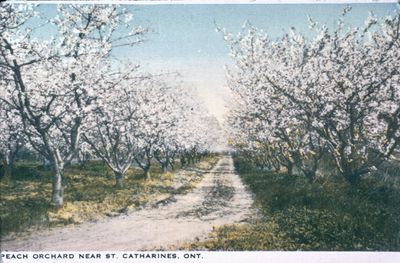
<box><xmin>185</xmin><ymin>158</ymin><xmax>400</xmax><ymax>251</ymax></box>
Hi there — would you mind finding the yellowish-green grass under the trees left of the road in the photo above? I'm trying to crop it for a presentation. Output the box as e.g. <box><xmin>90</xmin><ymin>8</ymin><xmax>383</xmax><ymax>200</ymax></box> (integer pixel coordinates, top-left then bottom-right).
<box><xmin>0</xmin><ymin>157</ymin><xmax>218</xmax><ymax>236</ymax></box>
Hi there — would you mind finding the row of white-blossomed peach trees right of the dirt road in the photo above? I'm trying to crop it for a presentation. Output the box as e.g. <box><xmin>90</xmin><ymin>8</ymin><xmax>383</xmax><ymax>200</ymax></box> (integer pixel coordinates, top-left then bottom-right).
<box><xmin>220</xmin><ymin>8</ymin><xmax>400</xmax><ymax>183</ymax></box>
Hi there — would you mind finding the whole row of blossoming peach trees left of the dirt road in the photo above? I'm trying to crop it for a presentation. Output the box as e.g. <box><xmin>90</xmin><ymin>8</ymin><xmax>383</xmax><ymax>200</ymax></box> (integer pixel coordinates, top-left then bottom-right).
<box><xmin>0</xmin><ymin>4</ymin><xmax>222</xmax><ymax>206</ymax></box>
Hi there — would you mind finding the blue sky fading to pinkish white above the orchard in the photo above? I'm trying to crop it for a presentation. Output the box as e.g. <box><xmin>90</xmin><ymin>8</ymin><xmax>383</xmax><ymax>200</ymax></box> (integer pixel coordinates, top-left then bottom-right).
<box><xmin>36</xmin><ymin>3</ymin><xmax>398</xmax><ymax>118</ymax></box>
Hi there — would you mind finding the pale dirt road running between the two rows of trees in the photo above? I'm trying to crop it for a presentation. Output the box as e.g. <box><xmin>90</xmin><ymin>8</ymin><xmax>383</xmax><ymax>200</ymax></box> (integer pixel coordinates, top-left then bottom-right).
<box><xmin>1</xmin><ymin>156</ymin><xmax>252</xmax><ymax>251</ymax></box>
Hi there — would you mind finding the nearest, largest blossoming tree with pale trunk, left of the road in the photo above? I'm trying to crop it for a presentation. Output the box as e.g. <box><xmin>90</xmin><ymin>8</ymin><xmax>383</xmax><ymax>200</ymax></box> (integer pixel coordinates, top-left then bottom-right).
<box><xmin>0</xmin><ymin>4</ymin><xmax>145</xmax><ymax>206</ymax></box>
